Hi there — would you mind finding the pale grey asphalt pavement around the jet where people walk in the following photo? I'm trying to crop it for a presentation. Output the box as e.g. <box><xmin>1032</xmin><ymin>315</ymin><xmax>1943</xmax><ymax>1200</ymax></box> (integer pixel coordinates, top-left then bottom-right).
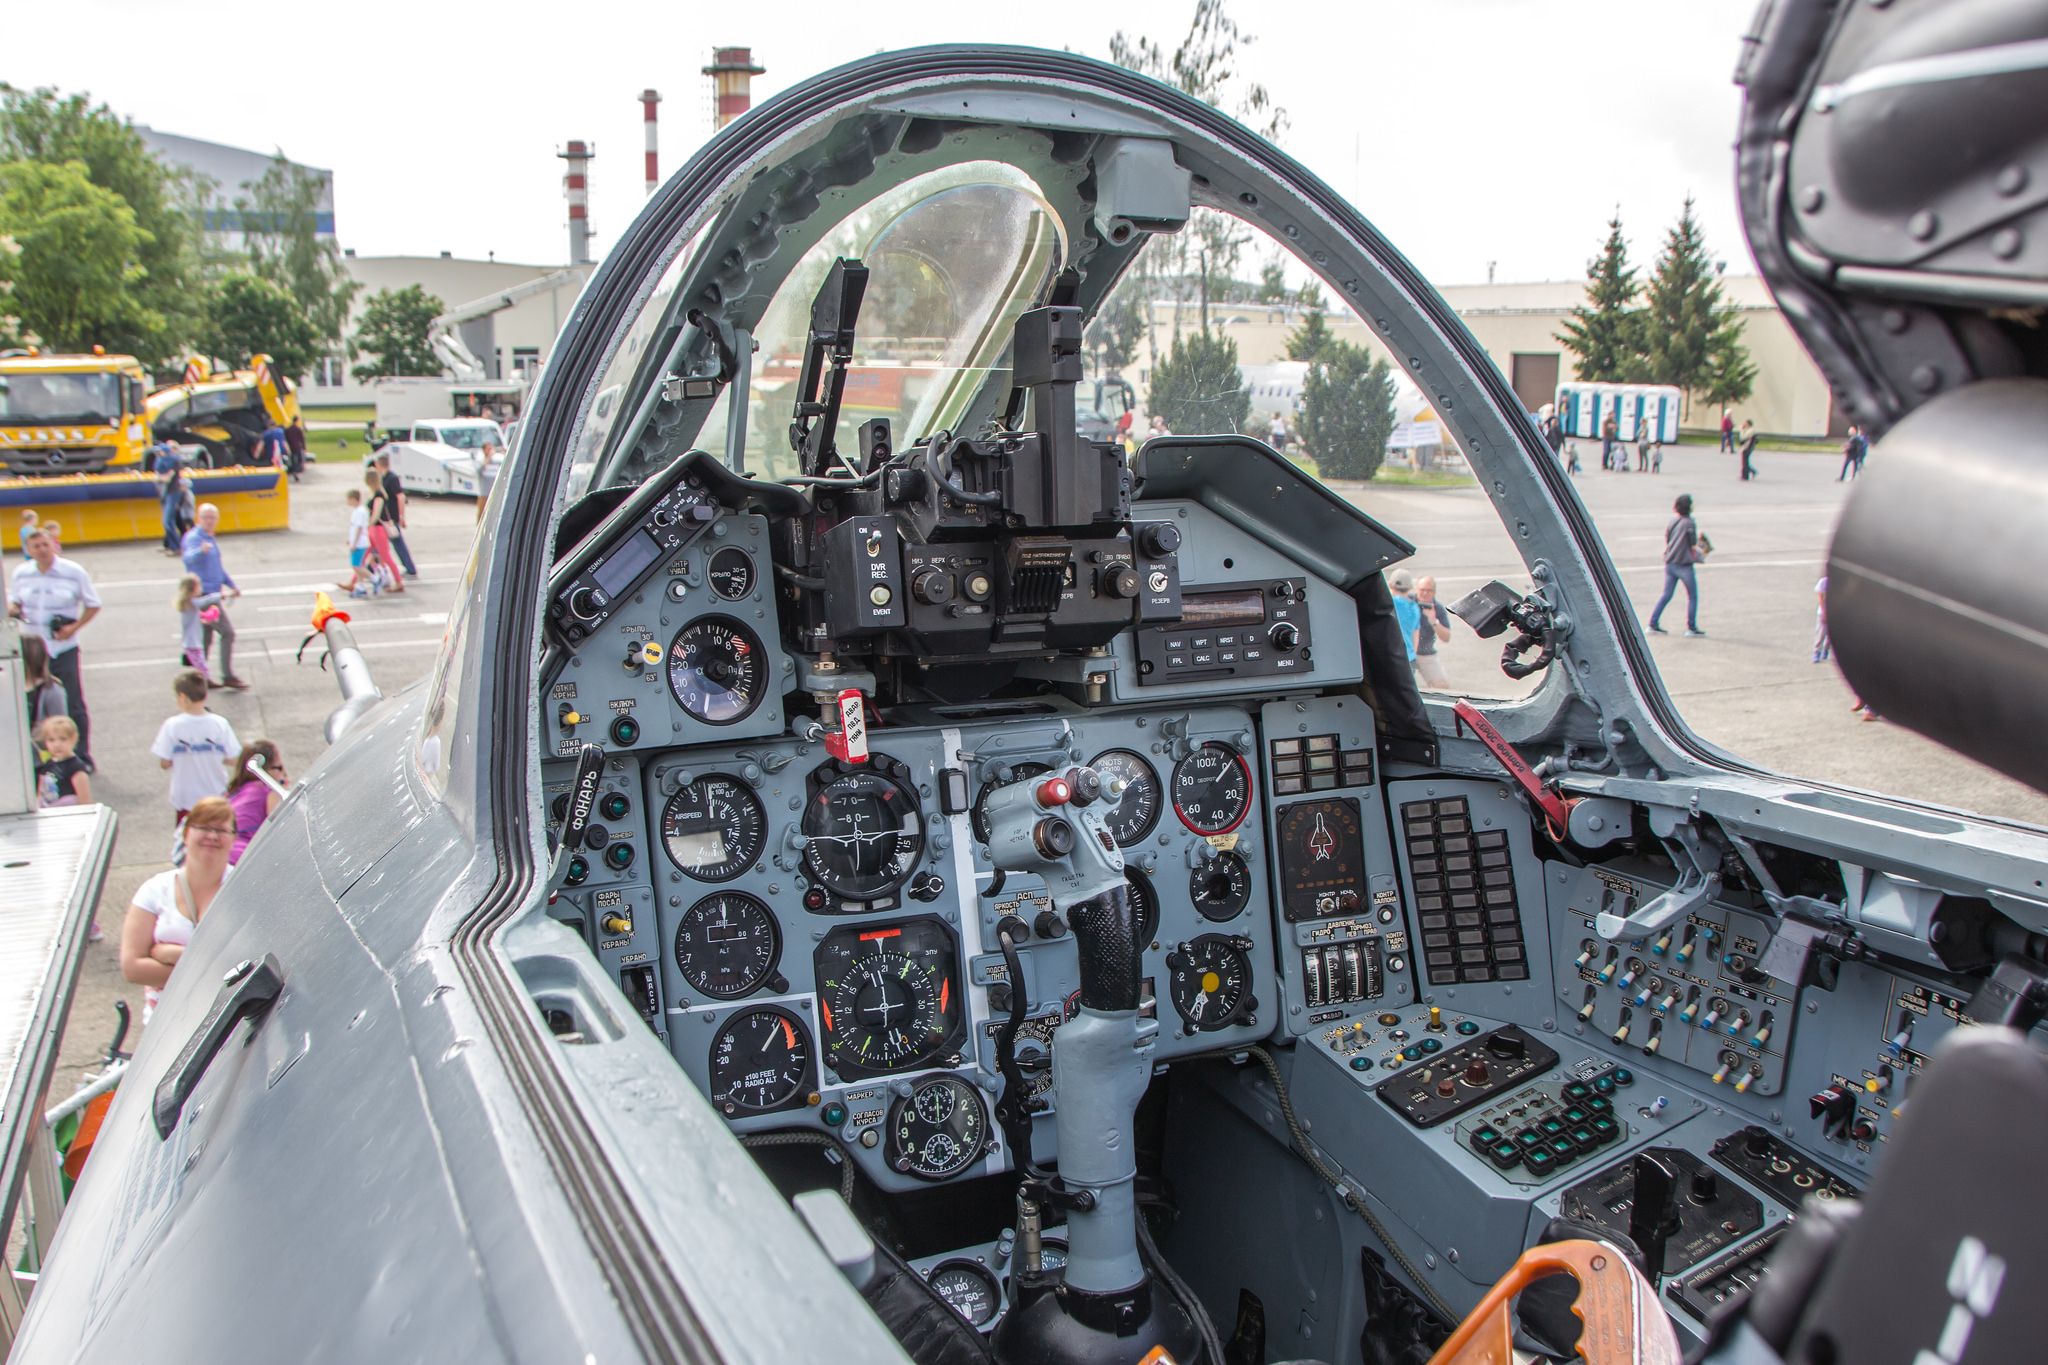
<box><xmin>32</xmin><ymin>437</ymin><xmax>2048</xmax><ymax>1129</ymax></box>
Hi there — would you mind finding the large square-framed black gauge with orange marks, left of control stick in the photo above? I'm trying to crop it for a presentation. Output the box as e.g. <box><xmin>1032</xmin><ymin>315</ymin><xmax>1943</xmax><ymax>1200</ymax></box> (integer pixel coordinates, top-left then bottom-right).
<box><xmin>811</xmin><ymin>921</ymin><xmax>961</xmax><ymax>1078</ymax></box>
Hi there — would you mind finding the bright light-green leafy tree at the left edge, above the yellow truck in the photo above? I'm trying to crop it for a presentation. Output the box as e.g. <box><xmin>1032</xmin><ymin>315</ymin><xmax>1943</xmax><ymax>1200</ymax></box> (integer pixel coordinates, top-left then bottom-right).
<box><xmin>0</xmin><ymin>162</ymin><xmax>162</xmax><ymax>350</ymax></box>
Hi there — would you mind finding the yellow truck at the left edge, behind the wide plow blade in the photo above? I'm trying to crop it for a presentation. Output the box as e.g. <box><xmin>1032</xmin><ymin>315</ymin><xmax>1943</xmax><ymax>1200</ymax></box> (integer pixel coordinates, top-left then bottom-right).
<box><xmin>0</xmin><ymin>352</ymin><xmax>150</xmax><ymax>475</ymax></box>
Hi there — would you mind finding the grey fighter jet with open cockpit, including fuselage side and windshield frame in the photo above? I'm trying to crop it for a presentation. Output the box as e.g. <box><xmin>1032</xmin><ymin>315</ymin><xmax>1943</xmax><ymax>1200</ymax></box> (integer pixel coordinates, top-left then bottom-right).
<box><xmin>23</xmin><ymin>26</ymin><xmax>2048</xmax><ymax>1365</ymax></box>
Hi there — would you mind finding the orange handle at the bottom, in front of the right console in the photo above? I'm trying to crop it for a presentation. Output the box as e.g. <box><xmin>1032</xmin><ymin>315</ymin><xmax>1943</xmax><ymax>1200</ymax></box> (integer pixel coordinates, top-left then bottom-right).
<box><xmin>1430</xmin><ymin>1240</ymin><xmax>1683</xmax><ymax>1365</ymax></box>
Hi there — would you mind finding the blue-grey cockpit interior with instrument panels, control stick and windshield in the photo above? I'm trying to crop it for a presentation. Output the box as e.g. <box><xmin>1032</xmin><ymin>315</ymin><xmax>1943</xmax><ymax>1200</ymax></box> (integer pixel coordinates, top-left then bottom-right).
<box><xmin>495</xmin><ymin>42</ymin><xmax>2048</xmax><ymax>1363</ymax></box>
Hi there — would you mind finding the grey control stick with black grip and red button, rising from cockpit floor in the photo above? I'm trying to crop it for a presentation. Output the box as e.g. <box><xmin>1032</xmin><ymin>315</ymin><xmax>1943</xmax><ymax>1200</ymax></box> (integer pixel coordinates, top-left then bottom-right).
<box><xmin>983</xmin><ymin>767</ymin><xmax>1196</xmax><ymax>1365</ymax></box>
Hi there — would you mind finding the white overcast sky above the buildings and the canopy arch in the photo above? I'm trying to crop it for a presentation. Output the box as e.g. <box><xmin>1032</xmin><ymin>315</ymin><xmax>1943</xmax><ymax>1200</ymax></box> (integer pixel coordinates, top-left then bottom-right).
<box><xmin>0</xmin><ymin>0</ymin><xmax>1755</xmax><ymax>284</ymax></box>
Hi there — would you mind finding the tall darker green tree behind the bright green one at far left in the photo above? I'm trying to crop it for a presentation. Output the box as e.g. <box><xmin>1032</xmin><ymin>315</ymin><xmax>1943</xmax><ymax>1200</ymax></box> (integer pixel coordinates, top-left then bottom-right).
<box><xmin>0</xmin><ymin>86</ymin><xmax>205</xmax><ymax>366</ymax></box>
